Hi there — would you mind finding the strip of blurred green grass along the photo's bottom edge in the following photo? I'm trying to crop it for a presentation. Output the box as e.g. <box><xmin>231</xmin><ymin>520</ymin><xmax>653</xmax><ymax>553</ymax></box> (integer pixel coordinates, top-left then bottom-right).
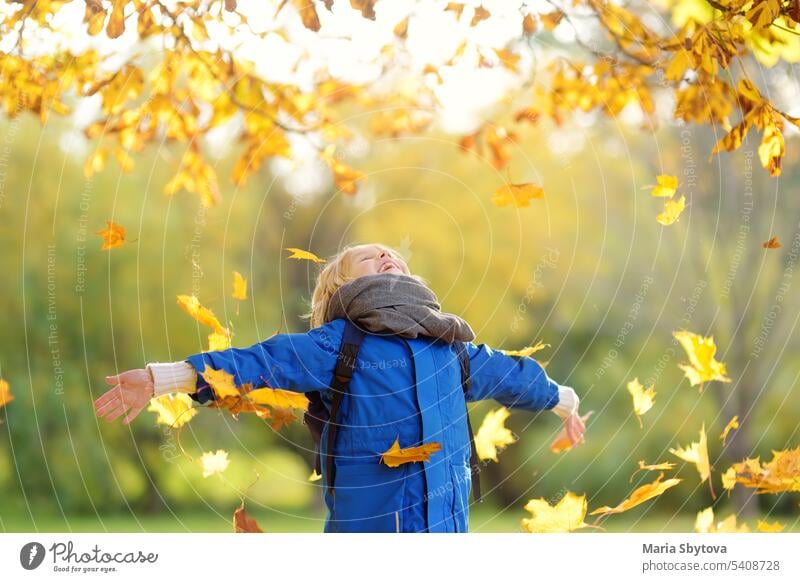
<box><xmin>0</xmin><ymin>506</ymin><xmax>800</xmax><ymax>533</ymax></box>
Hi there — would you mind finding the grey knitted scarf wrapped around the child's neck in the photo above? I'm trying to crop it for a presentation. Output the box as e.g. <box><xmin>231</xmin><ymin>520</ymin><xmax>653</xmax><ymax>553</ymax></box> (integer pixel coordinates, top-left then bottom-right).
<box><xmin>325</xmin><ymin>273</ymin><xmax>475</xmax><ymax>343</ymax></box>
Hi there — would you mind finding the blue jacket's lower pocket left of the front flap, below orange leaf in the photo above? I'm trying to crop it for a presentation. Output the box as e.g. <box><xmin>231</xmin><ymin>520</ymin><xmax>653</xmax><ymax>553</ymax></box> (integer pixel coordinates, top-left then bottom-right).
<box><xmin>330</xmin><ymin>463</ymin><xmax>408</xmax><ymax>533</ymax></box>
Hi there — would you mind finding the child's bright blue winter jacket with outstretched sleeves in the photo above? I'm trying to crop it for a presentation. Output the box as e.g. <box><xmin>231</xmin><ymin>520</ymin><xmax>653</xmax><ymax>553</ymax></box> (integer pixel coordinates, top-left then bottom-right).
<box><xmin>186</xmin><ymin>319</ymin><xmax>559</xmax><ymax>532</ymax></box>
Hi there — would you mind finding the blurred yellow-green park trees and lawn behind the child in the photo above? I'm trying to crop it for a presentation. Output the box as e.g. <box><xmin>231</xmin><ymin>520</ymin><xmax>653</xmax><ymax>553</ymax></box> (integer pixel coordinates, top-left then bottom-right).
<box><xmin>0</xmin><ymin>104</ymin><xmax>800</xmax><ymax>531</ymax></box>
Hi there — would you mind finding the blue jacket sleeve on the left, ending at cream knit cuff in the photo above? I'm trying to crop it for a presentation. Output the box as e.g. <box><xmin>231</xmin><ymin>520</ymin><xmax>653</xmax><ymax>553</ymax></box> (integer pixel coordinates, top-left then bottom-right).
<box><xmin>185</xmin><ymin>320</ymin><xmax>344</xmax><ymax>404</ymax></box>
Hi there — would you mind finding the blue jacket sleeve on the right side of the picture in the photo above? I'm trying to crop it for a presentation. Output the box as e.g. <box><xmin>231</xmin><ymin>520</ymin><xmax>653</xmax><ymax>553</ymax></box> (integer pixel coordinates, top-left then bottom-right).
<box><xmin>466</xmin><ymin>342</ymin><xmax>564</xmax><ymax>411</ymax></box>
